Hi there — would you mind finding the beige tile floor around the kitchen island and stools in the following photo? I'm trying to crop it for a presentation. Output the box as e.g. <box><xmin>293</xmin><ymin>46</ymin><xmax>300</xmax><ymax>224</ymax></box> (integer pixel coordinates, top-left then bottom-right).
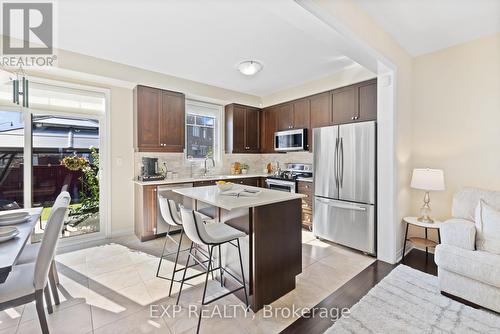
<box><xmin>0</xmin><ymin>231</ymin><xmax>374</xmax><ymax>334</ymax></box>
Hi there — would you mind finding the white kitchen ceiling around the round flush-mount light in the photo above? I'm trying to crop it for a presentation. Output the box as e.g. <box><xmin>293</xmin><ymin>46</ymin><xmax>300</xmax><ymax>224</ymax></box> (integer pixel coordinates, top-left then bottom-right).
<box><xmin>52</xmin><ymin>0</ymin><xmax>356</xmax><ymax>96</ymax></box>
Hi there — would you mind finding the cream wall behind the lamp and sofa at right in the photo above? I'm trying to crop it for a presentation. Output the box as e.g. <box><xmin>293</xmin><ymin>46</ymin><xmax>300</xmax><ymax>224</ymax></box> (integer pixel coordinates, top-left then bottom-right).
<box><xmin>412</xmin><ymin>34</ymin><xmax>500</xmax><ymax>240</ymax></box>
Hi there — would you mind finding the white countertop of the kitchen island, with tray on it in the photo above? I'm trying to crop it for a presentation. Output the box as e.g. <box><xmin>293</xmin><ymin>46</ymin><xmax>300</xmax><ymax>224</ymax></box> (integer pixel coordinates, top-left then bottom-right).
<box><xmin>172</xmin><ymin>185</ymin><xmax>306</xmax><ymax>211</ymax></box>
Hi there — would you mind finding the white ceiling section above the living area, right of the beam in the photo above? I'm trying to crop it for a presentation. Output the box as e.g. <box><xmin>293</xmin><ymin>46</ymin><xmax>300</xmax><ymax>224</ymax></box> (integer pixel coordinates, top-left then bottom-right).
<box><xmin>355</xmin><ymin>0</ymin><xmax>500</xmax><ymax>56</ymax></box>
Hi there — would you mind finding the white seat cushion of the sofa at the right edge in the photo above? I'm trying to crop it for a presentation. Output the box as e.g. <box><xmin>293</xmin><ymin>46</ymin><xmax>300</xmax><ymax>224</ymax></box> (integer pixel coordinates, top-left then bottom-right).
<box><xmin>434</xmin><ymin>244</ymin><xmax>500</xmax><ymax>288</ymax></box>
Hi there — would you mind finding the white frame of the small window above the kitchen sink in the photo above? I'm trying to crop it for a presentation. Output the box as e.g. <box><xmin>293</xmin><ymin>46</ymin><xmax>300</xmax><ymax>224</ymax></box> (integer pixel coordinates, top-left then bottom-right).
<box><xmin>184</xmin><ymin>99</ymin><xmax>224</xmax><ymax>164</ymax></box>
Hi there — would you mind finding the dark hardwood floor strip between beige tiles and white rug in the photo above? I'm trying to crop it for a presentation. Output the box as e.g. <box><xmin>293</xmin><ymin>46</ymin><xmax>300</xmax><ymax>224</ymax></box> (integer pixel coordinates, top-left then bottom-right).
<box><xmin>281</xmin><ymin>249</ymin><xmax>437</xmax><ymax>334</ymax></box>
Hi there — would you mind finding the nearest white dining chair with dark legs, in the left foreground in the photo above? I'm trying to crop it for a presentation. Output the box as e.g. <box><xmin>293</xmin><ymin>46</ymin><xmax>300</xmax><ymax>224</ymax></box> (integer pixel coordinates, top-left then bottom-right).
<box><xmin>0</xmin><ymin>192</ymin><xmax>71</xmax><ymax>334</ymax></box>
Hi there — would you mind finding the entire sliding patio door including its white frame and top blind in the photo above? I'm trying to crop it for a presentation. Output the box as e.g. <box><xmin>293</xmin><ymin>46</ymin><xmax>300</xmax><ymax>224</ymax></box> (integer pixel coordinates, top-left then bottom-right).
<box><xmin>0</xmin><ymin>77</ymin><xmax>106</xmax><ymax>242</ymax></box>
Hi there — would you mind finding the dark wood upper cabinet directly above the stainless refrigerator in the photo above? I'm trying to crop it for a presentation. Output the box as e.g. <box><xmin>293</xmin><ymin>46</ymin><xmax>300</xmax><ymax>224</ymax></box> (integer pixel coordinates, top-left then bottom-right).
<box><xmin>331</xmin><ymin>79</ymin><xmax>377</xmax><ymax>124</ymax></box>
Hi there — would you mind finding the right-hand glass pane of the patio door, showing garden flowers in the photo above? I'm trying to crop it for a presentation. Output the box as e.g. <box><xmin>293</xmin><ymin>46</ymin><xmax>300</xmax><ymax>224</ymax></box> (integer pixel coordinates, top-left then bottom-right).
<box><xmin>31</xmin><ymin>114</ymin><xmax>100</xmax><ymax>241</ymax></box>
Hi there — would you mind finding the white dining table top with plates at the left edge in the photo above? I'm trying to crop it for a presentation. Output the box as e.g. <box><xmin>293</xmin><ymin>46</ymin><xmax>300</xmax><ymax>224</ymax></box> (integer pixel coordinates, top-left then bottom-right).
<box><xmin>0</xmin><ymin>208</ymin><xmax>43</xmax><ymax>284</ymax></box>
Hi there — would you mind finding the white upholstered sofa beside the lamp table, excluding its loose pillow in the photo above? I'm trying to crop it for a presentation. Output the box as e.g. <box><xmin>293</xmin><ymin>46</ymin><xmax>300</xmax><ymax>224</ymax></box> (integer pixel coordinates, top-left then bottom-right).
<box><xmin>434</xmin><ymin>188</ymin><xmax>500</xmax><ymax>312</ymax></box>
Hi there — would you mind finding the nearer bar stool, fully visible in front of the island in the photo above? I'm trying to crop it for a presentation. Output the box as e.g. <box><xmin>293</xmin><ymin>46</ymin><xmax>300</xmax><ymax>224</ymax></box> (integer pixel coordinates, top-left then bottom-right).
<box><xmin>176</xmin><ymin>206</ymin><xmax>248</xmax><ymax>333</ymax></box>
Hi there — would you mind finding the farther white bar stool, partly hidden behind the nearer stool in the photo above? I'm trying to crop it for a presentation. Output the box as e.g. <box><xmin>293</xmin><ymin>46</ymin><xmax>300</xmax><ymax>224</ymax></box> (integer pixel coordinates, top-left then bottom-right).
<box><xmin>156</xmin><ymin>195</ymin><xmax>212</xmax><ymax>297</ymax></box>
